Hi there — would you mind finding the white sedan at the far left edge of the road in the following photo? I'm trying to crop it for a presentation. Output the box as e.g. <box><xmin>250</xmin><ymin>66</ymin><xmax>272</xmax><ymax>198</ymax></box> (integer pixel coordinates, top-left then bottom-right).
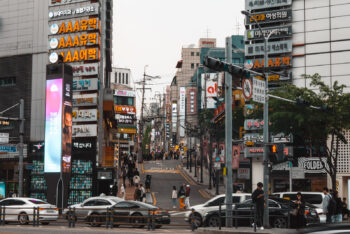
<box><xmin>0</xmin><ymin>197</ymin><xmax>58</xmax><ymax>225</ymax></box>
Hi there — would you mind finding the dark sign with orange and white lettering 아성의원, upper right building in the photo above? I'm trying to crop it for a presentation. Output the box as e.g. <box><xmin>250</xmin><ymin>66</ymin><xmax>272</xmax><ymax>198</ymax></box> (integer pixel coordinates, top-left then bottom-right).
<box><xmin>246</xmin><ymin>9</ymin><xmax>292</xmax><ymax>24</ymax></box>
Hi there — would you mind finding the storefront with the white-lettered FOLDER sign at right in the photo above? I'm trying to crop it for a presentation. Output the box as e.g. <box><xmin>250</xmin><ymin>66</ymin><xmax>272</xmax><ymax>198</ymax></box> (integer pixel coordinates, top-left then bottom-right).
<box><xmin>270</xmin><ymin>157</ymin><xmax>327</xmax><ymax>192</ymax></box>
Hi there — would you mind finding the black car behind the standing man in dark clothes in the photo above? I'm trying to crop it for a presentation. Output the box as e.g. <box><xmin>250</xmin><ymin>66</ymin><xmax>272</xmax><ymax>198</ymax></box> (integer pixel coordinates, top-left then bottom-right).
<box><xmin>204</xmin><ymin>198</ymin><xmax>319</xmax><ymax>228</ymax></box>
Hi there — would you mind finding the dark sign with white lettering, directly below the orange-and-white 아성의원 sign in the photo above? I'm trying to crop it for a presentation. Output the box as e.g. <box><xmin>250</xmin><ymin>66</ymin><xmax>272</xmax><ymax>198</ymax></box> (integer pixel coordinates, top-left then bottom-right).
<box><xmin>245</xmin><ymin>25</ymin><xmax>292</xmax><ymax>40</ymax></box>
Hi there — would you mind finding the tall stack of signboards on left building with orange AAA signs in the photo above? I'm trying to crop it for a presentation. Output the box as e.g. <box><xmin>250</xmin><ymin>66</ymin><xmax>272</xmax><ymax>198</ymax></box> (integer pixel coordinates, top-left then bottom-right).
<box><xmin>48</xmin><ymin>0</ymin><xmax>102</xmax><ymax>204</ymax></box>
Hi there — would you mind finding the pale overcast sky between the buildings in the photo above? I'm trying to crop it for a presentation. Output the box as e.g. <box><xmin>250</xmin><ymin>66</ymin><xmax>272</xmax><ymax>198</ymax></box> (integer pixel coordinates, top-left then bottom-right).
<box><xmin>113</xmin><ymin>0</ymin><xmax>244</xmax><ymax>111</ymax></box>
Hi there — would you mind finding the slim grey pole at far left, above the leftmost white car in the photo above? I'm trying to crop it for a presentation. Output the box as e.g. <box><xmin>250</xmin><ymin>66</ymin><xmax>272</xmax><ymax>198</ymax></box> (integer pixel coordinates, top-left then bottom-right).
<box><xmin>18</xmin><ymin>99</ymin><xmax>24</xmax><ymax>197</ymax></box>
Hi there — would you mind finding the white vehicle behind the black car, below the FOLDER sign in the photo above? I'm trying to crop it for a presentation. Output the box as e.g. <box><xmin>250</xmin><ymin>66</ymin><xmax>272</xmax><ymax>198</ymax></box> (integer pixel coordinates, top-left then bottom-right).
<box><xmin>272</xmin><ymin>192</ymin><xmax>326</xmax><ymax>223</ymax></box>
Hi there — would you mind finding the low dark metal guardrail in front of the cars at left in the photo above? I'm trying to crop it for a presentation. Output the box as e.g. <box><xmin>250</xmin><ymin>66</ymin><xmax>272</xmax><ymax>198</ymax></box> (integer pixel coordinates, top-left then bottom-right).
<box><xmin>0</xmin><ymin>206</ymin><xmax>197</xmax><ymax>231</ymax></box>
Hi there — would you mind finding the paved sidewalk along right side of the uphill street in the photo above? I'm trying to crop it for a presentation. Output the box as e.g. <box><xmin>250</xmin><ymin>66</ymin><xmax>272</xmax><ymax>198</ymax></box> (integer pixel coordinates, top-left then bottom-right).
<box><xmin>179</xmin><ymin>161</ymin><xmax>226</xmax><ymax>197</ymax></box>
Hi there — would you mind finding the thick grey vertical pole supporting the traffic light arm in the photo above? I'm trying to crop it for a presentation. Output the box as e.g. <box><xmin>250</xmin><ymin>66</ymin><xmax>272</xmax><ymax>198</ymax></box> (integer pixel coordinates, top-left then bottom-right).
<box><xmin>225</xmin><ymin>37</ymin><xmax>232</xmax><ymax>227</ymax></box>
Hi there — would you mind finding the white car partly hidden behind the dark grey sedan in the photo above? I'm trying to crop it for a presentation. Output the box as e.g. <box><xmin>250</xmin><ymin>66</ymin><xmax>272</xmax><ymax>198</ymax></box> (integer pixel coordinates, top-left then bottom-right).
<box><xmin>65</xmin><ymin>196</ymin><xmax>124</xmax><ymax>227</ymax></box>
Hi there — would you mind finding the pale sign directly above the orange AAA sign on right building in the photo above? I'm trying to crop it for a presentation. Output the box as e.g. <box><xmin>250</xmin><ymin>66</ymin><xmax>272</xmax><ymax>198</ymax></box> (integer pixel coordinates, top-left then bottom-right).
<box><xmin>245</xmin><ymin>40</ymin><xmax>293</xmax><ymax>56</ymax></box>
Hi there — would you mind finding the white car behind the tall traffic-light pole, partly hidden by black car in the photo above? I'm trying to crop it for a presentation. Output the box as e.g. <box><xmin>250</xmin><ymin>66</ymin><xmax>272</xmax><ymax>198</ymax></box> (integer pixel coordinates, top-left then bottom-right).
<box><xmin>185</xmin><ymin>193</ymin><xmax>251</xmax><ymax>227</ymax></box>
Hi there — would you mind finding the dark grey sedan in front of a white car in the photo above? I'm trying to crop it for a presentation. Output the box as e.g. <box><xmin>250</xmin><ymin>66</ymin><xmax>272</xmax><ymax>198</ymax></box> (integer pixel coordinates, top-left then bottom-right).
<box><xmin>106</xmin><ymin>201</ymin><xmax>170</xmax><ymax>228</ymax></box>
